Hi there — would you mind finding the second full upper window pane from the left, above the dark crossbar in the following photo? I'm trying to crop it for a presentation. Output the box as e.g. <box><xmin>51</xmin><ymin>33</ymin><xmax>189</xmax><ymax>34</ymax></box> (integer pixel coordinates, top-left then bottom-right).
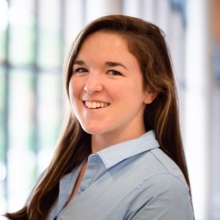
<box><xmin>38</xmin><ymin>0</ymin><xmax>62</xmax><ymax>69</ymax></box>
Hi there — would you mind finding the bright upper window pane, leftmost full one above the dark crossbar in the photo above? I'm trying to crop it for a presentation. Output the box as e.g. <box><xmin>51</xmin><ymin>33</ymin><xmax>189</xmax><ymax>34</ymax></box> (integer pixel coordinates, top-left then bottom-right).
<box><xmin>9</xmin><ymin>4</ymin><xmax>35</xmax><ymax>66</ymax></box>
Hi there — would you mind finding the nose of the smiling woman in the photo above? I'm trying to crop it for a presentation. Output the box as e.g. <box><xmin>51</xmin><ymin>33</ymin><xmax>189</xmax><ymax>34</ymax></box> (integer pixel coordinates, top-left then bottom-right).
<box><xmin>84</xmin><ymin>73</ymin><xmax>103</xmax><ymax>94</ymax></box>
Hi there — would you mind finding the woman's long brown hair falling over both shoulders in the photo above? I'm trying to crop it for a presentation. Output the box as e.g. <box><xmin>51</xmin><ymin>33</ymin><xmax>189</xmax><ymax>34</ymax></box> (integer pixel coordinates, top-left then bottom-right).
<box><xmin>6</xmin><ymin>15</ymin><xmax>190</xmax><ymax>220</ymax></box>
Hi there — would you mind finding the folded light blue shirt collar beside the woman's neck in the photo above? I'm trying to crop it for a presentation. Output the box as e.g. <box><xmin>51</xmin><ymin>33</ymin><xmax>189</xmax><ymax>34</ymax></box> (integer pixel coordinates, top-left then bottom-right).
<box><xmin>97</xmin><ymin>130</ymin><xmax>159</xmax><ymax>169</ymax></box>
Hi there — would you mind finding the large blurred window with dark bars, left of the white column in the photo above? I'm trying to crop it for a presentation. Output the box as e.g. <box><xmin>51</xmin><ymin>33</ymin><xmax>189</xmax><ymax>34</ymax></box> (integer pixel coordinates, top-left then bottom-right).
<box><xmin>0</xmin><ymin>0</ymin><xmax>189</xmax><ymax>213</ymax></box>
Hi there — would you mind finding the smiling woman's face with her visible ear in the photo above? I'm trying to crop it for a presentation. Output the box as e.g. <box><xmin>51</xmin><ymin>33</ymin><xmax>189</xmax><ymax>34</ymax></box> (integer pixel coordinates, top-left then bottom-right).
<box><xmin>69</xmin><ymin>32</ymin><xmax>156</xmax><ymax>137</ymax></box>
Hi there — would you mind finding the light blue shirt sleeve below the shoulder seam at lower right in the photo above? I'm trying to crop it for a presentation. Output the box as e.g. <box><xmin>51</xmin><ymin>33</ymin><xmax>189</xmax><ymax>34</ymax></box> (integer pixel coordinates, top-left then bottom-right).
<box><xmin>125</xmin><ymin>174</ymin><xmax>194</xmax><ymax>220</ymax></box>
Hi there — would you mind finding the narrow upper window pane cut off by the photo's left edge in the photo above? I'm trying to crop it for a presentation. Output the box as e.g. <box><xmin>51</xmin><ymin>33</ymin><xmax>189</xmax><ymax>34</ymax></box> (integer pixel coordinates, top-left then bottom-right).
<box><xmin>0</xmin><ymin>0</ymin><xmax>8</xmax><ymax>62</ymax></box>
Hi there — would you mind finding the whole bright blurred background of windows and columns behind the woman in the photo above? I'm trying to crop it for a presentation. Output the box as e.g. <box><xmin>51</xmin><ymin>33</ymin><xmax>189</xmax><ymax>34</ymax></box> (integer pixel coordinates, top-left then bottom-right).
<box><xmin>0</xmin><ymin>0</ymin><xmax>220</xmax><ymax>220</ymax></box>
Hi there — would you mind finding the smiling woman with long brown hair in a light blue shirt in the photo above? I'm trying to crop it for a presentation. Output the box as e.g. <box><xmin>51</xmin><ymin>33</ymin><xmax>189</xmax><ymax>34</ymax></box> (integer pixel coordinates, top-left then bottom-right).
<box><xmin>6</xmin><ymin>15</ymin><xmax>193</xmax><ymax>220</ymax></box>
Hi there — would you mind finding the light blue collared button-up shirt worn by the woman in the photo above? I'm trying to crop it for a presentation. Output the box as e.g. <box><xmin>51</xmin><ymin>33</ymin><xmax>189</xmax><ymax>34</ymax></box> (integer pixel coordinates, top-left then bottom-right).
<box><xmin>31</xmin><ymin>131</ymin><xmax>194</xmax><ymax>220</ymax></box>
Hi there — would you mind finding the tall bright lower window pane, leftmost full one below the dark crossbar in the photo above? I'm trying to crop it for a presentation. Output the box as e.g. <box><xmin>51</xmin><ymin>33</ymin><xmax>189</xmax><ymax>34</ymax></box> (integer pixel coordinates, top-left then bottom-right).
<box><xmin>8</xmin><ymin>69</ymin><xmax>36</xmax><ymax>211</ymax></box>
